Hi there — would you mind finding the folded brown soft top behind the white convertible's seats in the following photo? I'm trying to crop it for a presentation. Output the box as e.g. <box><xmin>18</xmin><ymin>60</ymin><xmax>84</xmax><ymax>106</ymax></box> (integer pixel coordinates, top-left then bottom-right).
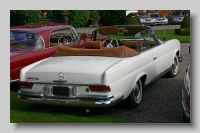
<box><xmin>53</xmin><ymin>46</ymin><xmax>140</xmax><ymax>58</ymax></box>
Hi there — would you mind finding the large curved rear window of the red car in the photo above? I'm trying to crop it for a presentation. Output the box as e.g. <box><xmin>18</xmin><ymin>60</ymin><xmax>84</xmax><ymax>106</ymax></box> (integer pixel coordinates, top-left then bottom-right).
<box><xmin>10</xmin><ymin>31</ymin><xmax>44</xmax><ymax>50</ymax></box>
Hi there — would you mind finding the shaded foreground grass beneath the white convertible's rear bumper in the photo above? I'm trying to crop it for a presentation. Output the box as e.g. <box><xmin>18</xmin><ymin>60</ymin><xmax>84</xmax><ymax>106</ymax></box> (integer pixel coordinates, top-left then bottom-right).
<box><xmin>10</xmin><ymin>91</ymin><xmax>128</xmax><ymax>123</ymax></box>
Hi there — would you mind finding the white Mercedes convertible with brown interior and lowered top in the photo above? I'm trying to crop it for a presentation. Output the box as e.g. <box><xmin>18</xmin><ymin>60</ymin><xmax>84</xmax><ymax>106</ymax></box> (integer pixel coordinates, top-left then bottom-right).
<box><xmin>18</xmin><ymin>25</ymin><xmax>182</xmax><ymax>108</ymax></box>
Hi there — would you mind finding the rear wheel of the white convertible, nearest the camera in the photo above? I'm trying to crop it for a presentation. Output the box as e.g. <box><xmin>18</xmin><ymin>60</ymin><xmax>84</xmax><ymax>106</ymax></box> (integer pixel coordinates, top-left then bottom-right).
<box><xmin>125</xmin><ymin>79</ymin><xmax>142</xmax><ymax>108</ymax></box>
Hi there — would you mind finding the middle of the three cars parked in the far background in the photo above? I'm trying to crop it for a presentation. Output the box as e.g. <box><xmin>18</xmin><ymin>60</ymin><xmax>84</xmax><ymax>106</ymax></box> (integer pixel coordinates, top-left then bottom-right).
<box><xmin>150</xmin><ymin>14</ymin><xmax>168</xmax><ymax>25</ymax></box>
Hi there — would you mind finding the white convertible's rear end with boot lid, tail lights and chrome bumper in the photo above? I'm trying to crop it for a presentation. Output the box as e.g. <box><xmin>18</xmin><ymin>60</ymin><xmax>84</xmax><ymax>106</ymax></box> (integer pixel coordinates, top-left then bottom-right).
<box><xmin>18</xmin><ymin>56</ymin><xmax>123</xmax><ymax>107</ymax></box>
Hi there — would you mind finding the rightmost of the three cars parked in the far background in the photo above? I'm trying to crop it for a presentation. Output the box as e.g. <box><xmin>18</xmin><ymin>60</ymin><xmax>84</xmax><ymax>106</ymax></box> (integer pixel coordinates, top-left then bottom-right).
<box><xmin>168</xmin><ymin>11</ymin><xmax>185</xmax><ymax>24</ymax></box>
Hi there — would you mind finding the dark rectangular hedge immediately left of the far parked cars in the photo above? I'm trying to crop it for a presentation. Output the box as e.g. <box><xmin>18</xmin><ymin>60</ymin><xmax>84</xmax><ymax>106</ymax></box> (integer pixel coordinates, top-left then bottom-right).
<box><xmin>100</xmin><ymin>10</ymin><xmax>126</xmax><ymax>26</ymax></box>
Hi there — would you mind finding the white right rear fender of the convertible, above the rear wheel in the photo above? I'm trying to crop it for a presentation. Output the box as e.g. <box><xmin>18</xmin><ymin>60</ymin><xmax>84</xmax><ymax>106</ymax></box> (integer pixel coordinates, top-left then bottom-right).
<box><xmin>102</xmin><ymin>51</ymin><xmax>154</xmax><ymax>99</ymax></box>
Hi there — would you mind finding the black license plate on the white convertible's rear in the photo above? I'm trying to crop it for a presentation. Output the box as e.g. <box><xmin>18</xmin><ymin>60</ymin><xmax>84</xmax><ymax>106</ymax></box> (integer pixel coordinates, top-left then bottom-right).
<box><xmin>53</xmin><ymin>86</ymin><xmax>69</xmax><ymax>96</ymax></box>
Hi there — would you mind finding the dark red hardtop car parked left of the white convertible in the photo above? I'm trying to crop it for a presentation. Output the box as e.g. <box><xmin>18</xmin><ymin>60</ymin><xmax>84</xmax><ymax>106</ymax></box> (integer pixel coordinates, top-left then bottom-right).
<box><xmin>10</xmin><ymin>24</ymin><xmax>107</xmax><ymax>83</ymax></box>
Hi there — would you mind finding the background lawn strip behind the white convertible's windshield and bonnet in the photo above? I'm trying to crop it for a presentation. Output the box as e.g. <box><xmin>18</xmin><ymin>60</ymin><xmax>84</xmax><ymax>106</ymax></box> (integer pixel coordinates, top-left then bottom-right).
<box><xmin>108</xmin><ymin>30</ymin><xmax>190</xmax><ymax>43</ymax></box>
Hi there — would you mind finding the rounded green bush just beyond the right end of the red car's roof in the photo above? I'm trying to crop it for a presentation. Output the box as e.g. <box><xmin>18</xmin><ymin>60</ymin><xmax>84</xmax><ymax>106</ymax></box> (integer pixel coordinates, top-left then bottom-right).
<box><xmin>69</xmin><ymin>10</ymin><xmax>89</xmax><ymax>28</ymax></box>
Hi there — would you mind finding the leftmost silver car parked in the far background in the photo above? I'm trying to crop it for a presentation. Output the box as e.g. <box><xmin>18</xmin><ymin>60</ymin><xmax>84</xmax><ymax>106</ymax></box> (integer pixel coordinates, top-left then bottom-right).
<box><xmin>126</xmin><ymin>12</ymin><xmax>156</xmax><ymax>26</ymax></box>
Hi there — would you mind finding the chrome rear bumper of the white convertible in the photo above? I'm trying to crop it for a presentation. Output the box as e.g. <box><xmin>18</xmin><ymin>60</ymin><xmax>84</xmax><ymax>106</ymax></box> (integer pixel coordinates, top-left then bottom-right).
<box><xmin>17</xmin><ymin>90</ymin><xmax>124</xmax><ymax>107</ymax></box>
